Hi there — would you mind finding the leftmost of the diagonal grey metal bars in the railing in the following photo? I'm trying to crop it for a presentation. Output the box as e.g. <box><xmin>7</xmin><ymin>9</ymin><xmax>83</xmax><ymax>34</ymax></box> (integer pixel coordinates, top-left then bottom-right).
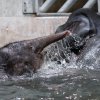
<box><xmin>39</xmin><ymin>0</ymin><xmax>56</xmax><ymax>13</ymax></box>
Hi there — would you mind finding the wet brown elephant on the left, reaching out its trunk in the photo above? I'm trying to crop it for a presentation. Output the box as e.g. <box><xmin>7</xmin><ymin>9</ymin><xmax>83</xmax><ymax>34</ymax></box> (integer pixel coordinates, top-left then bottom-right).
<box><xmin>0</xmin><ymin>31</ymin><xmax>69</xmax><ymax>75</ymax></box>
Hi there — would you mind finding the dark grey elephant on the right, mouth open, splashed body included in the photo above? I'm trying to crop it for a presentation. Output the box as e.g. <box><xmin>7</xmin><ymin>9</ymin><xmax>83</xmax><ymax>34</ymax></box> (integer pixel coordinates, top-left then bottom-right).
<box><xmin>56</xmin><ymin>9</ymin><xmax>100</xmax><ymax>69</ymax></box>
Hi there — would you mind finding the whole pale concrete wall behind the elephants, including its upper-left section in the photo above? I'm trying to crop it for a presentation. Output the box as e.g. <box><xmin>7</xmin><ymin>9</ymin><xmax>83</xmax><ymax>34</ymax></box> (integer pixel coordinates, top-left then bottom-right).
<box><xmin>0</xmin><ymin>0</ymin><xmax>67</xmax><ymax>47</ymax></box>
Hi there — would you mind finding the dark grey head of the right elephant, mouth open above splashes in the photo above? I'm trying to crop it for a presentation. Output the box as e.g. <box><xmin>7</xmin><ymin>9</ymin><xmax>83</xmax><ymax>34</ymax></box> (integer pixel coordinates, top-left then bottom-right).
<box><xmin>56</xmin><ymin>8</ymin><xmax>96</xmax><ymax>54</ymax></box>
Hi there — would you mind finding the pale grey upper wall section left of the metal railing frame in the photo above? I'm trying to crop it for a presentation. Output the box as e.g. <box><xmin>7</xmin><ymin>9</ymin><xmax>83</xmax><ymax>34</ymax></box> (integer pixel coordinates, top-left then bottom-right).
<box><xmin>0</xmin><ymin>0</ymin><xmax>23</xmax><ymax>17</ymax></box>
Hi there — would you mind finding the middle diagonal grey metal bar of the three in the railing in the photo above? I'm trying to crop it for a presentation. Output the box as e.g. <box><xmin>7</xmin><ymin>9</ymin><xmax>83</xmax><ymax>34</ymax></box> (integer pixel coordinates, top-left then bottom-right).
<box><xmin>58</xmin><ymin>0</ymin><xmax>78</xmax><ymax>13</ymax></box>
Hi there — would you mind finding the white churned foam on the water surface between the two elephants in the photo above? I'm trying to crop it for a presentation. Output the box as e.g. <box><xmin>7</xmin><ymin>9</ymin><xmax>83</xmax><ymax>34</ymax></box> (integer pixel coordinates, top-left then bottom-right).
<box><xmin>37</xmin><ymin>52</ymin><xmax>78</xmax><ymax>78</ymax></box>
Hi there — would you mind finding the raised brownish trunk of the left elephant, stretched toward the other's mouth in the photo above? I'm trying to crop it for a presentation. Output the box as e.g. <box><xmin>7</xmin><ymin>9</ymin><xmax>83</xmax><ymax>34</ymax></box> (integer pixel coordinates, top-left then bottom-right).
<box><xmin>35</xmin><ymin>31</ymin><xmax>70</xmax><ymax>53</ymax></box>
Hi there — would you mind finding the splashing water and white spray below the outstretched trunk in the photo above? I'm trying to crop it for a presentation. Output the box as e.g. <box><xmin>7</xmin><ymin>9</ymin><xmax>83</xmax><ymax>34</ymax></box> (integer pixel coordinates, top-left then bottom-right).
<box><xmin>38</xmin><ymin>37</ymin><xmax>82</xmax><ymax>77</ymax></box>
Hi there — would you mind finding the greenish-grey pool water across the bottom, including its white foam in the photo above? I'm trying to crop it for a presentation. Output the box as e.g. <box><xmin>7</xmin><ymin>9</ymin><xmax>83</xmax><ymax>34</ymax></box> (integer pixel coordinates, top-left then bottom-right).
<box><xmin>0</xmin><ymin>63</ymin><xmax>100</xmax><ymax>100</ymax></box>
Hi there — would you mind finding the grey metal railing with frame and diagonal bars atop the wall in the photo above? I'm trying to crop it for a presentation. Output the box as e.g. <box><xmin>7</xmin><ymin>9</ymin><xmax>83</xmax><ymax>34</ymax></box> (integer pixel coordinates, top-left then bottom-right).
<box><xmin>23</xmin><ymin>0</ymin><xmax>100</xmax><ymax>16</ymax></box>
